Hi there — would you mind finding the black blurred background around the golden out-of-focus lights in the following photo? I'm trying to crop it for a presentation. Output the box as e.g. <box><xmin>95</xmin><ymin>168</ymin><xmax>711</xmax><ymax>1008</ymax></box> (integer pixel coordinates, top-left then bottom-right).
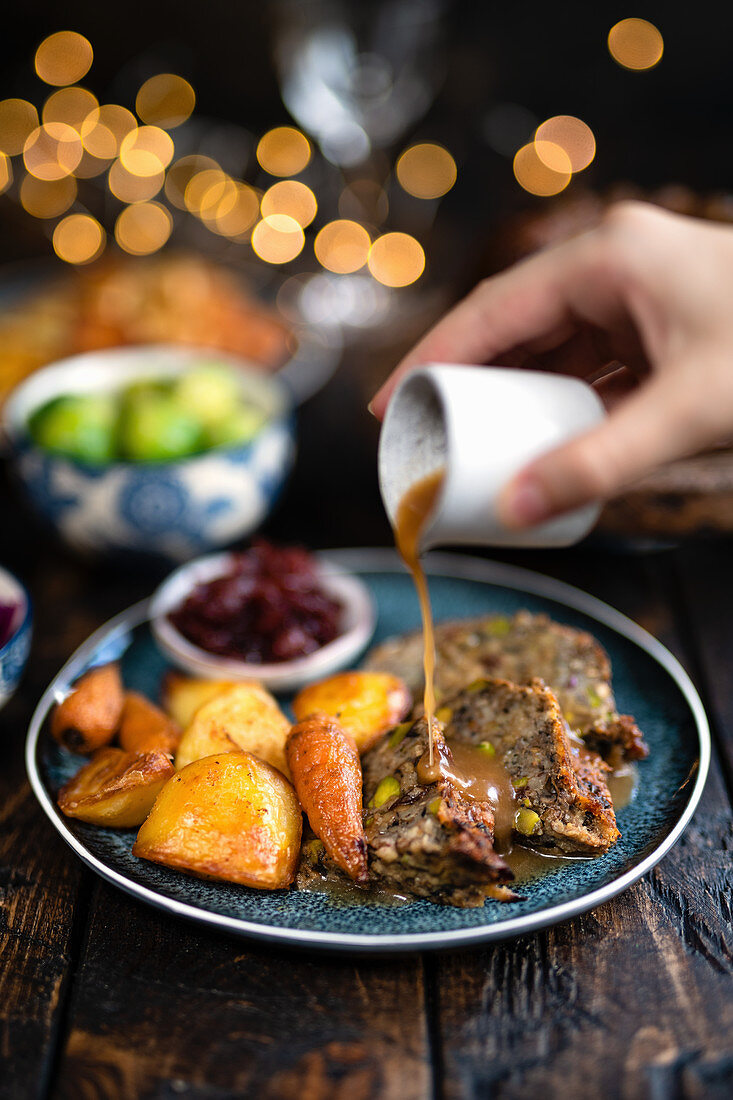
<box><xmin>0</xmin><ymin>0</ymin><xmax>733</xmax><ymax>558</ymax></box>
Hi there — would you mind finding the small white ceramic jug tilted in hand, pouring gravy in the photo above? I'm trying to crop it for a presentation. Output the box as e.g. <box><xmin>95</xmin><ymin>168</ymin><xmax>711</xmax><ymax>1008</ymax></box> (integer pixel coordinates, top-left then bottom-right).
<box><xmin>379</xmin><ymin>363</ymin><xmax>605</xmax><ymax>550</ymax></box>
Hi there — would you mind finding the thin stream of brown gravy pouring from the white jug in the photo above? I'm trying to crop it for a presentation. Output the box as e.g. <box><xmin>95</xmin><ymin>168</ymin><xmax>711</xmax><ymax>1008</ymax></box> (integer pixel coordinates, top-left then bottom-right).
<box><xmin>394</xmin><ymin>469</ymin><xmax>446</xmax><ymax>765</ymax></box>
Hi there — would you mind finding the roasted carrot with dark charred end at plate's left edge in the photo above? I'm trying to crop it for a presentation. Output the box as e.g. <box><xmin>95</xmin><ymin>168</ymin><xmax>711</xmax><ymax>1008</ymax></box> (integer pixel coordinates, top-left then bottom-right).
<box><xmin>51</xmin><ymin>664</ymin><xmax>124</xmax><ymax>754</ymax></box>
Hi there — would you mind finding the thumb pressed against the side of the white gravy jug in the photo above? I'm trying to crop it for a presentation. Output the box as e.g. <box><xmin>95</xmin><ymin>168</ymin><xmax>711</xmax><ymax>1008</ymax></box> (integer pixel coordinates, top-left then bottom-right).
<box><xmin>499</xmin><ymin>377</ymin><xmax>711</xmax><ymax>530</ymax></box>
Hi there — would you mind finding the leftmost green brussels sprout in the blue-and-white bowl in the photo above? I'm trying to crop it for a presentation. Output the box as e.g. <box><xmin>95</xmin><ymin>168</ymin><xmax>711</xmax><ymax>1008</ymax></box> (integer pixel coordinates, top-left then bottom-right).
<box><xmin>29</xmin><ymin>394</ymin><xmax>117</xmax><ymax>462</ymax></box>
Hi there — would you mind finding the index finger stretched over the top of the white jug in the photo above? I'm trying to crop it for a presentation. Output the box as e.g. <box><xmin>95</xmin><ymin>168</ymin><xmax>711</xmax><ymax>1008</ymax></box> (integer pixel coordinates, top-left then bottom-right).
<box><xmin>370</xmin><ymin>234</ymin><xmax>620</xmax><ymax>419</ymax></box>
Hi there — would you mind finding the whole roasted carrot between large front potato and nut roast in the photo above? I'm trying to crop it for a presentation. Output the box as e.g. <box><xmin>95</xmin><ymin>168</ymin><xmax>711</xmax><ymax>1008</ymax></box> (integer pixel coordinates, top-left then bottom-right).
<box><xmin>287</xmin><ymin>715</ymin><xmax>368</xmax><ymax>882</ymax></box>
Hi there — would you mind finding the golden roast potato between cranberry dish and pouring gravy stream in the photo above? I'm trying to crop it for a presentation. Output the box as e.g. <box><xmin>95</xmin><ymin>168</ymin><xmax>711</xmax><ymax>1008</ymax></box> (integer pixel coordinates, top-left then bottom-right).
<box><xmin>293</xmin><ymin>672</ymin><xmax>413</xmax><ymax>752</ymax></box>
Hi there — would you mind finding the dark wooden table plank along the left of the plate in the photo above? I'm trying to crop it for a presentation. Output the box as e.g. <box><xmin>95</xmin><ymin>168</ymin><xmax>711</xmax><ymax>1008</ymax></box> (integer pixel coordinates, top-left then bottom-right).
<box><xmin>0</xmin><ymin>558</ymin><xmax>89</xmax><ymax>1100</ymax></box>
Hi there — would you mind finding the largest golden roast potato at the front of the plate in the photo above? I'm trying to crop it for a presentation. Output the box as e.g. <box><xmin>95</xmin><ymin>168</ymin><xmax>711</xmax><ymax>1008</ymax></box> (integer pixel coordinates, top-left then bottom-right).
<box><xmin>132</xmin><ymin>751</ymin><xmax>303</xmax><ymax>890</ymax></box>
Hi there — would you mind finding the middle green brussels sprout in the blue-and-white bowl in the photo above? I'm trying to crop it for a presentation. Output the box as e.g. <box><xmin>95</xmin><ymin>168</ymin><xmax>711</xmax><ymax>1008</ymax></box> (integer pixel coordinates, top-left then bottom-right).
<box><xmin>120</xmin><ymin>394</ymin><xmax>204</xmax><ymax>462</ymax></box>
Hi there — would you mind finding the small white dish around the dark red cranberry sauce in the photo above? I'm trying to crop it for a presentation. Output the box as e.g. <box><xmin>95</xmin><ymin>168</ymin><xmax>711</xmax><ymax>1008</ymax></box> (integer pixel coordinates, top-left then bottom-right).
<box><xmin>150</xmin><ymin>553</ymin><xmax>376</xmax><ymax>692</ymax></box>
